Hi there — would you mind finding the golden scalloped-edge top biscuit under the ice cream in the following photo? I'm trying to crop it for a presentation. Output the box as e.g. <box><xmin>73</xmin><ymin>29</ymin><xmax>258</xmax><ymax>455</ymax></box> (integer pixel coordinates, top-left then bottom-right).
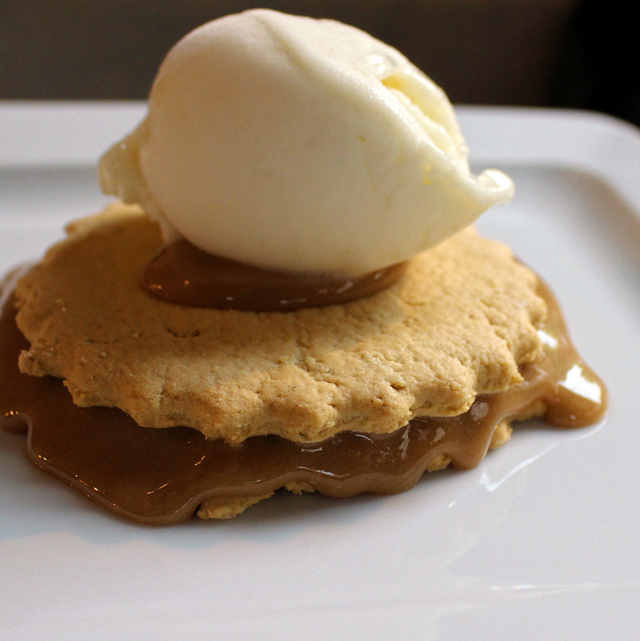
<box><xmin>17</xmin><ymin>205</ymin><xmax>546</xmax><ymax>442</ymax></box>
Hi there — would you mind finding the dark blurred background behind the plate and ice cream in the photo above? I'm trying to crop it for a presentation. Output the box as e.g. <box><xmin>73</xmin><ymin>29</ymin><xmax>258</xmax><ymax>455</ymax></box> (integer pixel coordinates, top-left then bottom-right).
<box><xmin>0</xmin><ymin>0</ymin><xmax>640</xmax><ymax>125</ymax></box>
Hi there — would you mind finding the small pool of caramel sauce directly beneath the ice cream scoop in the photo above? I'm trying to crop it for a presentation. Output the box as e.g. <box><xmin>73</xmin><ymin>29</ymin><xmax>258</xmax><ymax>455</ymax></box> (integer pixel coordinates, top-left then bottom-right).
<box><xmin>142</xmin><ymin>240</ymin><xmax>407</xmax><ymax>312</ymax></box>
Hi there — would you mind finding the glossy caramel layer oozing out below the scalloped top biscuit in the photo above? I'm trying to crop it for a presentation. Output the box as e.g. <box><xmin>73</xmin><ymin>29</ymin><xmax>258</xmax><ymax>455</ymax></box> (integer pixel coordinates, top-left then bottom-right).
<box><xmin>0</xmin><ymin>286</ymin><xmax>606</xmax><ymax>524</ymax></box>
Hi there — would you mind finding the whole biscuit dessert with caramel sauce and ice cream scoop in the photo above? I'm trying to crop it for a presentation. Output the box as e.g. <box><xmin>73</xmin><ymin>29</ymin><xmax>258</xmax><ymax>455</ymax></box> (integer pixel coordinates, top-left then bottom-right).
<box><xmin>0</xmin><ymin>10</ymin><xmax>605</xmax><ymax>523</ymax></box>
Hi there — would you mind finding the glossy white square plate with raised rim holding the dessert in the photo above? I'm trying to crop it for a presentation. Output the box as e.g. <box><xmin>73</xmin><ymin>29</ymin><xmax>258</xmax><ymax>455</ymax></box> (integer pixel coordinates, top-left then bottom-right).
<box><xmin>0</xmin><ymin>103</ymin><xmax>640</xmax><ymax>641</ymax></box>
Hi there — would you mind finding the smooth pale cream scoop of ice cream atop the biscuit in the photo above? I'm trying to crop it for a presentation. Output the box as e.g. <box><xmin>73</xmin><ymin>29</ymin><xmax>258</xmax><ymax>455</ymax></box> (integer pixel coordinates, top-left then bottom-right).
<box><xmin>100</xmin><ymin>9</ymin><xmax>513</xmax><ymax>274</ymax></box>
